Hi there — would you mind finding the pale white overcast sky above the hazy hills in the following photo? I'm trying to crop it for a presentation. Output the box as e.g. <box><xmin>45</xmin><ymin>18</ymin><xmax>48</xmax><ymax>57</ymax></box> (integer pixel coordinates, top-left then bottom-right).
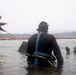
<box><xmin>0</xmin><ymin>0</ymin><xmax>76</xmax><ymax>33</ymax></box>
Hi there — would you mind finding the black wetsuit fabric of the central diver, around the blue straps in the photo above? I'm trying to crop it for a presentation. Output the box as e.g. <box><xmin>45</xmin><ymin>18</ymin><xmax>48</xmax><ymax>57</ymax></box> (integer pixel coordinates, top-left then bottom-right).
<box><xmin>27</xmin><ymin>33</ymin><xmax>63</xmax><ymax>65</ymax></box>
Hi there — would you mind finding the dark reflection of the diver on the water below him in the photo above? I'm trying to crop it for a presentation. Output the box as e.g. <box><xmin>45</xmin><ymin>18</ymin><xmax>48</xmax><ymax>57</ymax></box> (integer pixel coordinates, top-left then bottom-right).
<box><xmin>26</xmin><ymin>68</ymin><xmax>61</xmax><ymax>75</ymax></box>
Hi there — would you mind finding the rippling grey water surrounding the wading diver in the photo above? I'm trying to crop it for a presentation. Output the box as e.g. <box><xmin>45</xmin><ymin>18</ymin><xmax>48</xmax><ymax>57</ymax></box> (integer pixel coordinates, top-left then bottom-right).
<box><xmin>0</xmin><ymin>39</ymin><xmax>76</xmax><ymax>75</ymax></box>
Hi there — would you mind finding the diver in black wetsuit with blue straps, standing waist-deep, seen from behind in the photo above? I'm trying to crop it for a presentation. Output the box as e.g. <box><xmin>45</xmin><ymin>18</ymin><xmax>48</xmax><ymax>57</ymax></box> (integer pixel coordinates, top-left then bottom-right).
<box><xmin>27</xmin><ymin>21</ymin><xmax>63</xmax><ymax>67</ymax></box>
